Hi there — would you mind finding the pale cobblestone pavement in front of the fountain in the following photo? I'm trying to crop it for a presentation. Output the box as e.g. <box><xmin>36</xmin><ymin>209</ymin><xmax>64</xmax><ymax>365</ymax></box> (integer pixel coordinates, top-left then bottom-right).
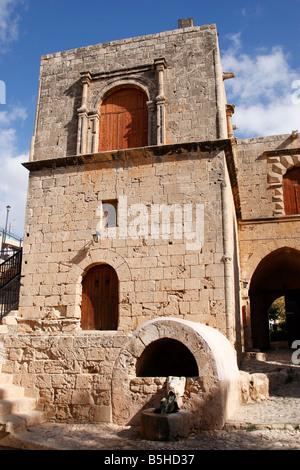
<box><xmin>0</xmin><ymin>350</ymin><xmax>300</xmax><ymax>451</ymax></box>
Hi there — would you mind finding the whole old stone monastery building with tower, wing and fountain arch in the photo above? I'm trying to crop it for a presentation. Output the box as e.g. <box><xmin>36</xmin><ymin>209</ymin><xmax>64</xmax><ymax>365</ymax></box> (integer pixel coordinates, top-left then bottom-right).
<box><xmin>1</xmin><ymin>20</ymin><xmax>300</xmax><ymax>427</ymax></box>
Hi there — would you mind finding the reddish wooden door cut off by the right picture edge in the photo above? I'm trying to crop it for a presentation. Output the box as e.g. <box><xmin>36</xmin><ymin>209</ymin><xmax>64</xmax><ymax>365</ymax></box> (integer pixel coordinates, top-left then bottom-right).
<box><xmin>282</xmin><ymin>167</ymin><xmax>300</xmax><ymax>215</ymax></box>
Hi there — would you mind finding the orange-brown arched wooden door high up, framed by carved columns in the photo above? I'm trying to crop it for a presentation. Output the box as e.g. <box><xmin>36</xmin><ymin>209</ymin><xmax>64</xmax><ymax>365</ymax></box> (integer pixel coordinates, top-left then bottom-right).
<box><xmin>99</xmin><ymin>87</ymin><xmax>148</xmax><ymax>152</ymax></box>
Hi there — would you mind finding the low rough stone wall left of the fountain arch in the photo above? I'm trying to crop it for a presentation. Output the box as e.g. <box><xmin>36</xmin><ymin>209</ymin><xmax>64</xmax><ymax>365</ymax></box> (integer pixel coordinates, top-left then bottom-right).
<box><xmin>0</xmin><ymin>332</ymin><xmax>128</xmax><ymax>423</ymax></box>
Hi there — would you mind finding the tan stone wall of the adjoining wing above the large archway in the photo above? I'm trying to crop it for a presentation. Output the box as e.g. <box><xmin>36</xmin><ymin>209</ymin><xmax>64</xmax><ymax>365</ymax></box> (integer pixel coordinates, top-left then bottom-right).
<box><xmin>236</xmin><ymin>135</ymin><xmax>300</xmax><ymax>350</ymax></box>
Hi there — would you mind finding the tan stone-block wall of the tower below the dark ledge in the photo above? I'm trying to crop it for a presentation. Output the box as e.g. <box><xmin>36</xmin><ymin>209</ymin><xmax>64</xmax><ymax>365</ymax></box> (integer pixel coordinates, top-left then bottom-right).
<box><xmin>19</xmin><ymin>140</ymin><xmax>236</xmax><ymax>342</ymax></box>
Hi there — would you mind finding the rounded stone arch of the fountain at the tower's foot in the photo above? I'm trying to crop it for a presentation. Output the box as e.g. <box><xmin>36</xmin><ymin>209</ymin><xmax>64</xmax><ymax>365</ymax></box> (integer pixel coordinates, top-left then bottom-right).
<box><xmin>112</xmin><ymin>317</ymin><xmax>239</xmax><ymax>429</ymax></box>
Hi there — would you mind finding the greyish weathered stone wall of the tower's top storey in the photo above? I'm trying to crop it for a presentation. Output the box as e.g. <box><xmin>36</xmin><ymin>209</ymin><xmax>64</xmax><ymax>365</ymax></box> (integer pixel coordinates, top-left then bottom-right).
<box><xmin>31</xmin><ymin>25</ymin><xmax>226</xmax><ymax>160</ymax></box>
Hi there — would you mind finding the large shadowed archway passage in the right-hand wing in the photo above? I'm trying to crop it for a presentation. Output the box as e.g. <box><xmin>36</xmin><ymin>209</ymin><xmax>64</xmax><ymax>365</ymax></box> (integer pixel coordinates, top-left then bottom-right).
<box><xmin>249</xmin><ymin>247</ymin><xmax>300</xmax><ymax>350</ymax></box>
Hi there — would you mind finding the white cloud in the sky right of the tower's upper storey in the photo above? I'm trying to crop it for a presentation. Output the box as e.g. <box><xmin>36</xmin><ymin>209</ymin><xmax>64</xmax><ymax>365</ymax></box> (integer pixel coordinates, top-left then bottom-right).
<box><xmin>222</xmin><ymin>33</ymin><xmax>300</xmax><ymax>137</ymax></box>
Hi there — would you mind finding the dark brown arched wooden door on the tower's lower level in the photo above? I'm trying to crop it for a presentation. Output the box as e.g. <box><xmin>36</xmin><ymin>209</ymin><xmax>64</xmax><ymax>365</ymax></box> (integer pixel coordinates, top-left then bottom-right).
<box><xmin>81</xmin><ymin>264</ymin><xmax>118</xmax><ymax>330</ymax></box>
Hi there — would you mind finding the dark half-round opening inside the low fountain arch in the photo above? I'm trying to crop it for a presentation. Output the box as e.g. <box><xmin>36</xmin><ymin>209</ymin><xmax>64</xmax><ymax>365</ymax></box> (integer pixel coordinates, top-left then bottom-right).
<box><xmin>136</xmin><ymin>338</ymin><xmax>199</xmax><ymax>377</ymax></box>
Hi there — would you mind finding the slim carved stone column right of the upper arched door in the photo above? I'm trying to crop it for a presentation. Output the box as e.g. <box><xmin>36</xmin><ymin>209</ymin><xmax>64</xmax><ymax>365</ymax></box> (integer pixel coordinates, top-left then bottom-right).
<box><xmin>154</xmin><ymin>57</ymin><xmax>167</xmax><ymax>145</ymax></box>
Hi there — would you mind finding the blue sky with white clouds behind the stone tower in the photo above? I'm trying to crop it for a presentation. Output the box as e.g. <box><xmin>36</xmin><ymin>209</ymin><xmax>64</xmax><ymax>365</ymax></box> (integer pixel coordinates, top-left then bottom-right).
<box><xmin>0</xmin><ymin>0</ymin><xmax>300</xmax><ymax>235</ymax></box>
